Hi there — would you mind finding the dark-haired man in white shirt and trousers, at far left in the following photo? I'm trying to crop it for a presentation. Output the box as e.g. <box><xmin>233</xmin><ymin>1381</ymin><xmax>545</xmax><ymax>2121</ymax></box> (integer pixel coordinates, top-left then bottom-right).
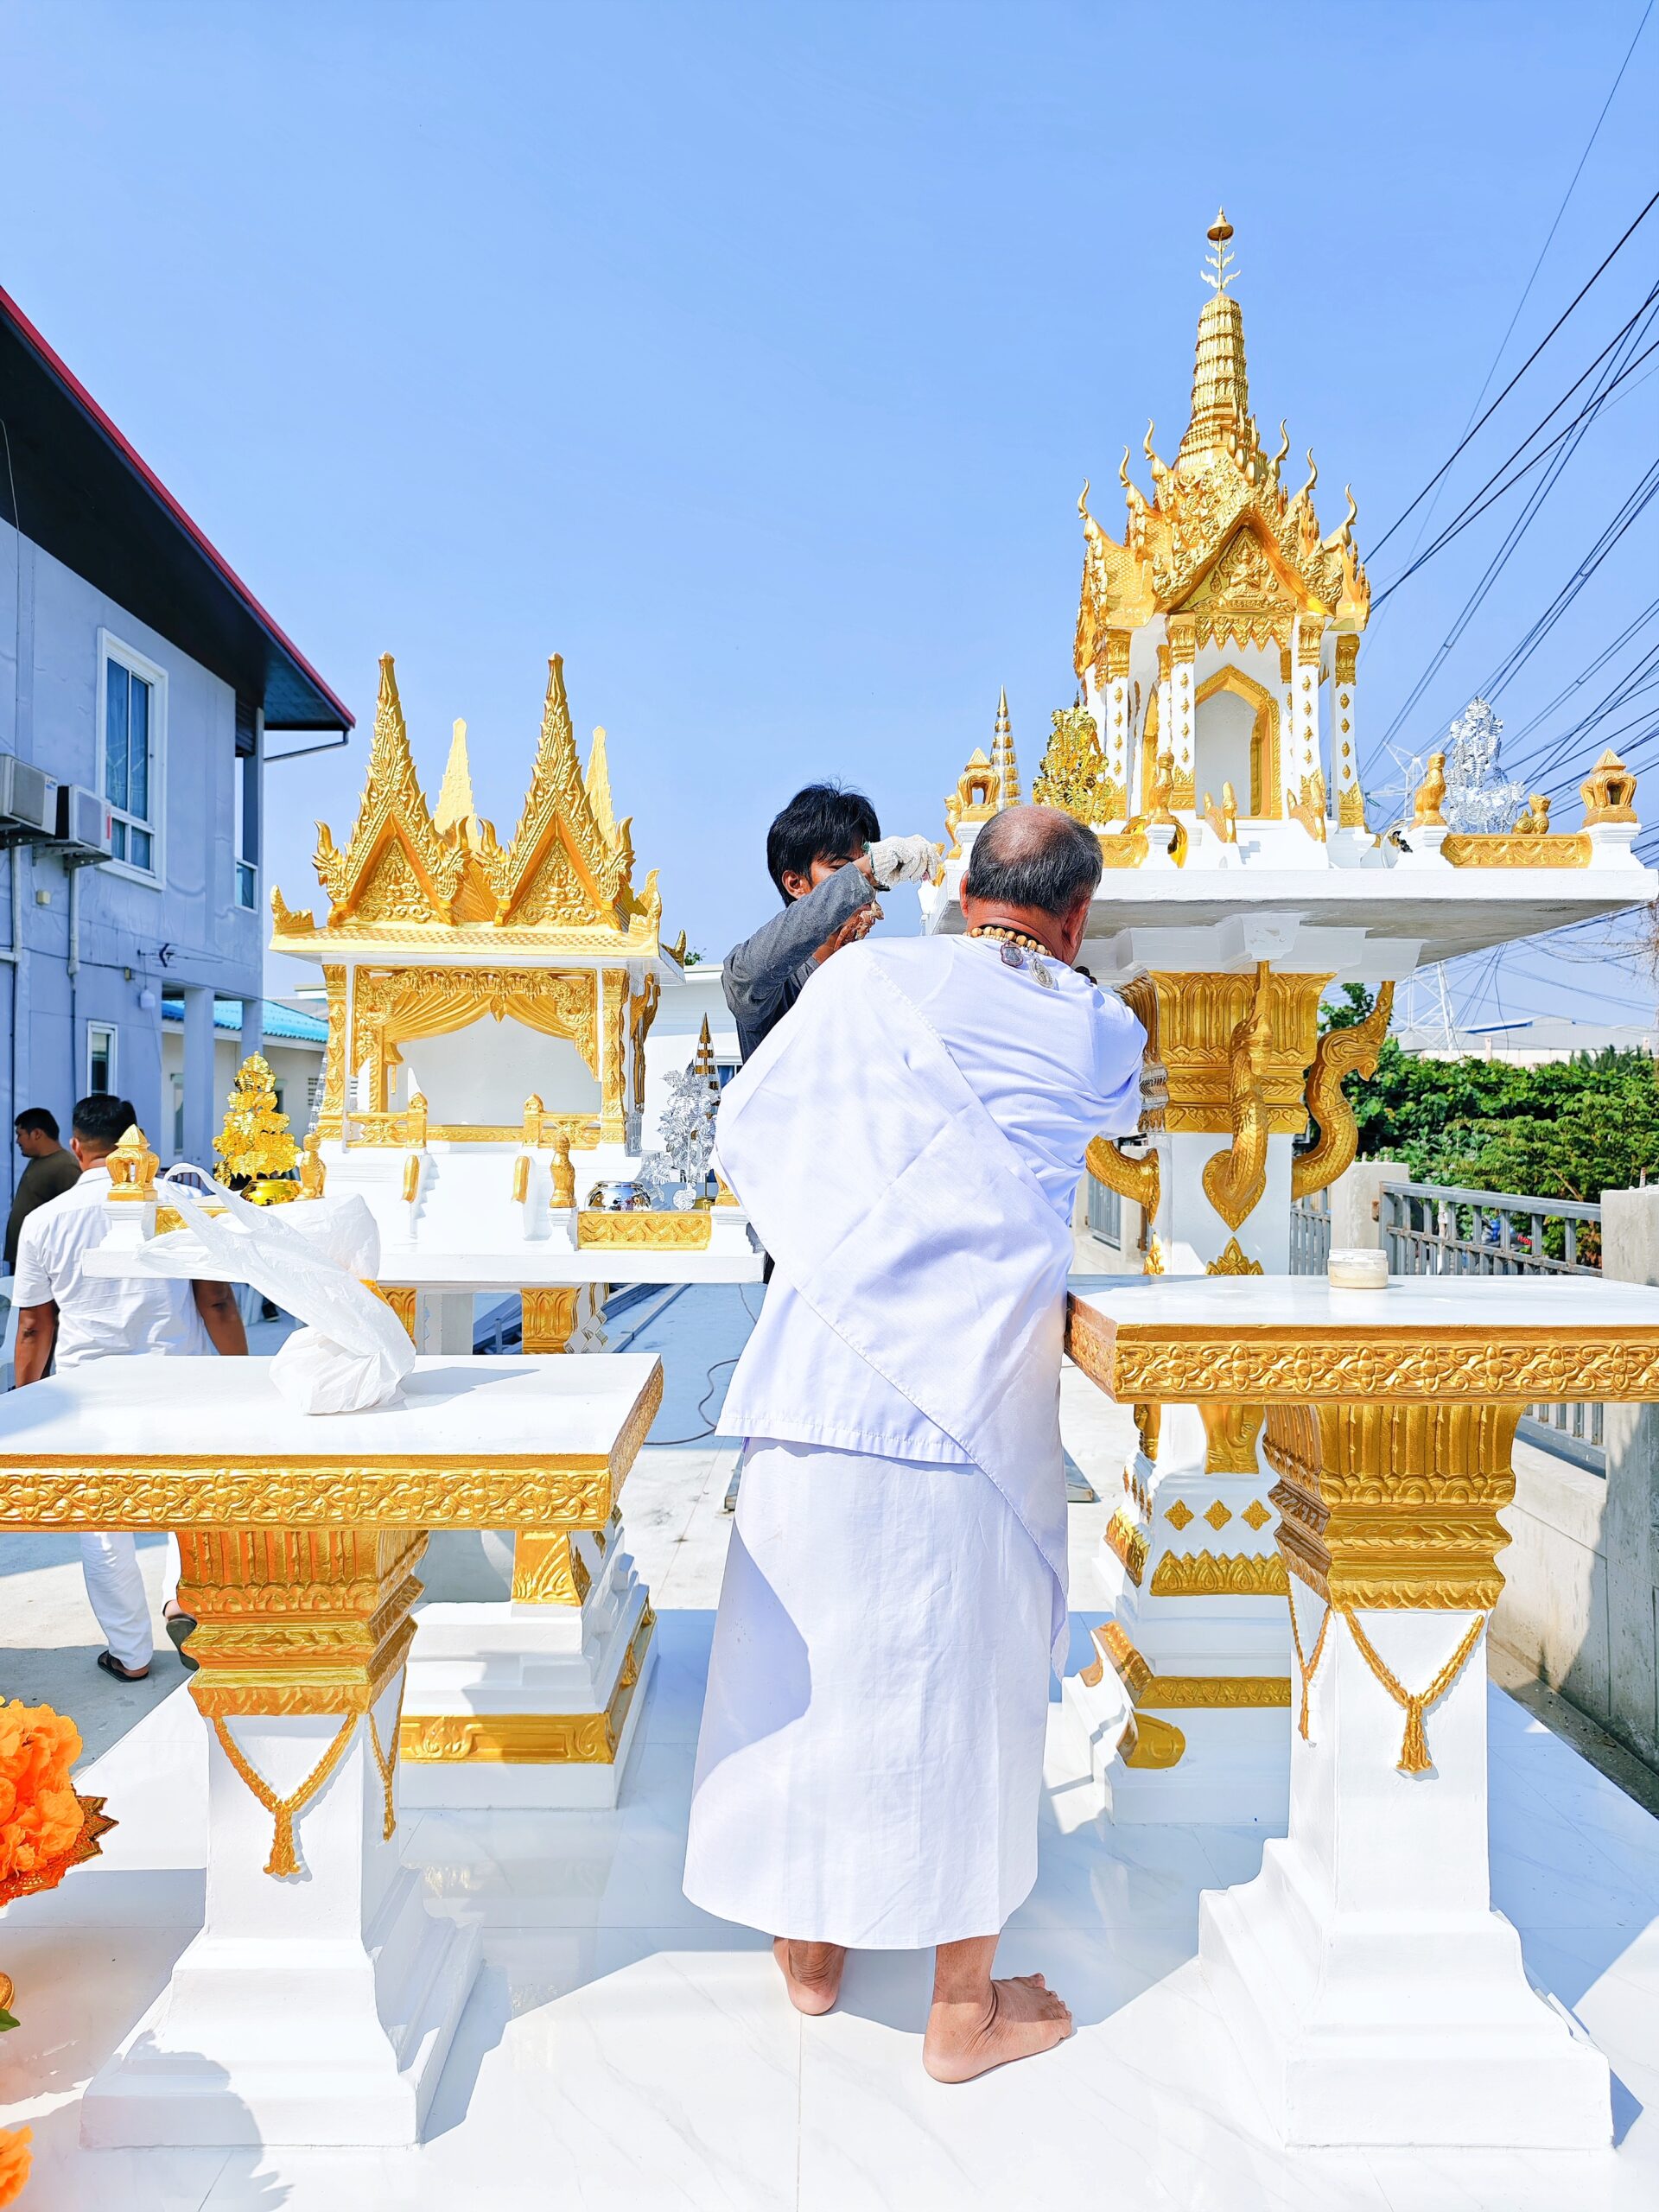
<box><xmin>13</xmin><ymin>1093</ymin><xmax>248</xmax><ymax>1681</ymax></box>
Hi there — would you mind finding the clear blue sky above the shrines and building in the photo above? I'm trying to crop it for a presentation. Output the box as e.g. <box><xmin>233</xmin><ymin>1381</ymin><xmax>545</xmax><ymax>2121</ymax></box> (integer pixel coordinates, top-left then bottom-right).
<box><xmin>0</xmin><ymin>0</ymin><xmax>1659</xmax><ymax>1020</ymax></box>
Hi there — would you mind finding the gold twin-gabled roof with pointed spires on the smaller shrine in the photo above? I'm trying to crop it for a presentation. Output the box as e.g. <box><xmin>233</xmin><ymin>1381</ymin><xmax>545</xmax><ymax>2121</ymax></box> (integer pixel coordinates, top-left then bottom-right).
<box><xmin>272</xmin><ymin>655</ymin><xmax>661</xmax><ymax>960</ymax></box>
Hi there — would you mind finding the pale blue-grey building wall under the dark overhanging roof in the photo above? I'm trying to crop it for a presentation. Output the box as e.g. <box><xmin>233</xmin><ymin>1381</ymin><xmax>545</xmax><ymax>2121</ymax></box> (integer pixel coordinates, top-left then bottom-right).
<box><xmin>0</xmin><ymin>518</ymin><xmax>264</xmax><ymax>1194</ymax></box>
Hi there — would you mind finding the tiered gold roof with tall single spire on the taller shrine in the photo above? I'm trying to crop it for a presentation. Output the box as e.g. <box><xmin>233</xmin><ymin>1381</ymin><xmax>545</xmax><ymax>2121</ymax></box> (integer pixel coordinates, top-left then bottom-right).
<box><xmin>1075</xmin><ymin>214</ymin><xmax>1371</xmax><ymax>675</ymax></box>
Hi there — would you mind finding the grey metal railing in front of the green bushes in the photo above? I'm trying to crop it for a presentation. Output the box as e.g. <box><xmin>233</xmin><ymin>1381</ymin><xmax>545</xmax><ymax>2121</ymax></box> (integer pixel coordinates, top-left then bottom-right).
<box><xmin>1380</xmin><ymin>1184</ymin><xmax>1608</xmax><ymax>1476</ymax></box>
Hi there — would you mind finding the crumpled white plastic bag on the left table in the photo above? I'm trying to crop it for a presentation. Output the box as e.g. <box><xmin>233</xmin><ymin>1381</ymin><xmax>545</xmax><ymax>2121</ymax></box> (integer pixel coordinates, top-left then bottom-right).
<box><xmin>162</xmin><ymin>1177</ymin><xmax>416</xmax><ymax>1414</ymax></box>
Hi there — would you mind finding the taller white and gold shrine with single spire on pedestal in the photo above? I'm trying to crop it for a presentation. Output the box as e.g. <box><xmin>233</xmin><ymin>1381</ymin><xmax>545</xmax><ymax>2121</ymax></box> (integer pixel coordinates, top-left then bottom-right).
<box><xmin>923</xmin><ymin>217</ymin><xmax>1659</xmax><ymax>1821</ymax></box>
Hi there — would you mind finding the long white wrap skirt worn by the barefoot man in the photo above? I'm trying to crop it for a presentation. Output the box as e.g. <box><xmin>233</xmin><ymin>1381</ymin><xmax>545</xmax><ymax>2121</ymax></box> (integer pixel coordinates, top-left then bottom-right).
<box><xmin>686</xmin><ymin>1438</ymin><xmax>1053</xmax><ymax>1948</ymax></box>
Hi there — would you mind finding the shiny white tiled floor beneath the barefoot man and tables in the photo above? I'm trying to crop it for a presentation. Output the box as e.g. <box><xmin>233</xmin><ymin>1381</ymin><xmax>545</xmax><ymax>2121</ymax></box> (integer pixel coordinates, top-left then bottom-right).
<box><xmin>13</xmin><ymin>1610</ymin><xmax>1659</xmax><ymax>2212</ymax></box>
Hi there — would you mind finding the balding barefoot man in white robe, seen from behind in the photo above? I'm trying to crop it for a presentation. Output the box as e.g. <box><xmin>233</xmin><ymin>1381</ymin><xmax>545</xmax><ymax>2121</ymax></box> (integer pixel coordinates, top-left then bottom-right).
<box><xmin>686</xmin><ymin>807</ymin><xmax>1146</xmax><ymax>2082</ymax></box>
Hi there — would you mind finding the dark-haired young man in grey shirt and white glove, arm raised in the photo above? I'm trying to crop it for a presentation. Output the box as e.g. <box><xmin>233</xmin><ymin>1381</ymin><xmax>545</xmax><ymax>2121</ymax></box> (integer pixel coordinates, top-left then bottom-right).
<box><xmin>721</xmin><ymin>783</ymin><xmax>938</xmax><ymax>1059</ymax></box>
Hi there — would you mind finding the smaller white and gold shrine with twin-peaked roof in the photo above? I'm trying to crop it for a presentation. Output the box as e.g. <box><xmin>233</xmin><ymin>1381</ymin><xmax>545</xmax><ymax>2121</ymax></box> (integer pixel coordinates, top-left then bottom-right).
<box><xmin>272</xmin><ymin>655</ymin><xmax>761</xmax><ymax>1808</ymax></box>
